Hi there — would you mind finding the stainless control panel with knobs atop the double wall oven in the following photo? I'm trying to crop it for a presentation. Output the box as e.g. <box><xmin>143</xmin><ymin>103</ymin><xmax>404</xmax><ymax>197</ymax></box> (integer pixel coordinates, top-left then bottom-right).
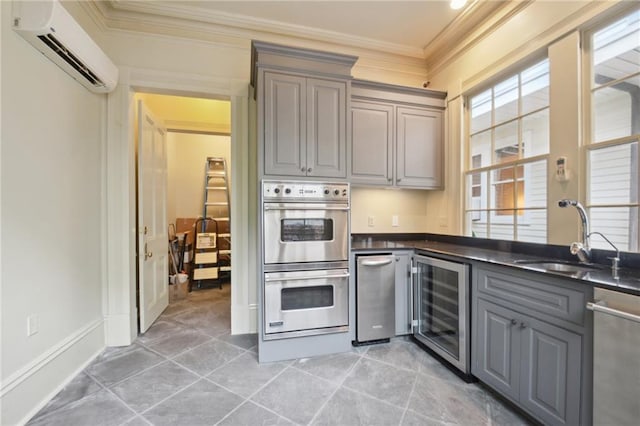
<box><xmin>262</xmin><ymin>181</ymin><xmax>349</xmax><ymax>202</ymax></box>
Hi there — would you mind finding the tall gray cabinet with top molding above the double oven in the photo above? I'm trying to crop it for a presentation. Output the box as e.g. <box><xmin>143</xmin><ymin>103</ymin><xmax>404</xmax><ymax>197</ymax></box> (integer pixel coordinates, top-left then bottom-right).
<box><xmin>251</xmin><ymin>42</ymin><xmax>357</xmax><ymax>178</ymax></box>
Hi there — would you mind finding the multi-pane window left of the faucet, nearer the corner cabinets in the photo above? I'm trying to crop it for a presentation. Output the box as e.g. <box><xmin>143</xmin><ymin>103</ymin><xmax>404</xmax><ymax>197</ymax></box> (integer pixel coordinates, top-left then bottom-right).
<box><xmin>465</xmin><ymin>59</ymin><xmax>549</xmax><ymax>243</ymax></box>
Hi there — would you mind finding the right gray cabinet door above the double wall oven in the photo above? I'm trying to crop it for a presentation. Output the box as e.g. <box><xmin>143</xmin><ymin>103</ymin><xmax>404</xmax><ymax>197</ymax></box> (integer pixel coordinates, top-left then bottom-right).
<box><xmin>306</xmin><ymin>78</ymin><xmax>347</xmax><ymax>178</ymax></box>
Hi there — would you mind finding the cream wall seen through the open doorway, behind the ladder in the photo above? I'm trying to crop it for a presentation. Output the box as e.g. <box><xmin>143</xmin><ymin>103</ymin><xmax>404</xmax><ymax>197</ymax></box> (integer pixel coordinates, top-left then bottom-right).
<box><xmin>167</xmin><ymin>132</ymin><xmax>231</xmax><ymax>223</ymax></box>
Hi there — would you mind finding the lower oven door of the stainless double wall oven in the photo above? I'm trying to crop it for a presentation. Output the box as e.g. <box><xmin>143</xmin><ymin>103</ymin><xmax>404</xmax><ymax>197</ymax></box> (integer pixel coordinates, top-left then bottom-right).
<box><xmin>264</xmin><ymin>269</ymin><xmax>349</xmax><ymax>339</ymax></box>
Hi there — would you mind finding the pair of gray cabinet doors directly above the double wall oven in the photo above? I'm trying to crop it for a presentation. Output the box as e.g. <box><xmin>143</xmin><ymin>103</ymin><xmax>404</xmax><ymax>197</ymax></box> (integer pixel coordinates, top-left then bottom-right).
<box><xmin>264</xmin><ymin>72</ymin><xmax>347</xmax><ymax>178</ymax></box>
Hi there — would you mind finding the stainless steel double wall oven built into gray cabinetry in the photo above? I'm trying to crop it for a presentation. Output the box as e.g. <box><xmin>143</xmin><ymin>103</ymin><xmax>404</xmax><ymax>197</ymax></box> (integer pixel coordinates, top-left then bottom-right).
<box><xmin>262</xmin><ymin>180</ymin><xmax>350</xmax><ymax>340</ymax></box>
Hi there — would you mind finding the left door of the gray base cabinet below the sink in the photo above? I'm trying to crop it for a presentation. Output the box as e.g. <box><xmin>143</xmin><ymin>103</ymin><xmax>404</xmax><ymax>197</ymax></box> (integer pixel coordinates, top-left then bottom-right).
<box><xmin>471</xmin><ymin>299</ymin><xmax>520</xmax><ymax>401</ymax></box>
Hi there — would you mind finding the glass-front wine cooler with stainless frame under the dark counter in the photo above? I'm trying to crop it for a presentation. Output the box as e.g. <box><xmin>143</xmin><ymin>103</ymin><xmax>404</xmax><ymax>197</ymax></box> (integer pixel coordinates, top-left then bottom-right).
<box><xmin>414</xmin><ymin>256</ymin><xmax>469</xmax><ymax>371</ymax></box>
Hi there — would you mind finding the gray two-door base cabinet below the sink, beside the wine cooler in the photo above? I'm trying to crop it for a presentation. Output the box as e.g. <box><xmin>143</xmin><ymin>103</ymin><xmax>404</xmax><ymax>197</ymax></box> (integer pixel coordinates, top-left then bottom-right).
<box><xmin>471</xmin><ymin>267</ymin><xmax>591</xmax><ymax>425</ymax></box>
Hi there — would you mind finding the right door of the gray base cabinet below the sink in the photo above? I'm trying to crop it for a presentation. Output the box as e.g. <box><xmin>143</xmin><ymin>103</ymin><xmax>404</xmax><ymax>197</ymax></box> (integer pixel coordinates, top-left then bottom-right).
<box><xmin>518</xmin><ymin>317</ymin><xmax>582</xmax><ymax>425</ymax></box>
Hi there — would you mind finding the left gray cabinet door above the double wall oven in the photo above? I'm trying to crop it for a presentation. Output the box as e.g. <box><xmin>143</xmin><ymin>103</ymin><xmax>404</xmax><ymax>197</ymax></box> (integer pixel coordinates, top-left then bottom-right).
<box><xmin>264</xmin><ymin>72</ymin><xmax>307</xmax><ymax>176</ymax></box>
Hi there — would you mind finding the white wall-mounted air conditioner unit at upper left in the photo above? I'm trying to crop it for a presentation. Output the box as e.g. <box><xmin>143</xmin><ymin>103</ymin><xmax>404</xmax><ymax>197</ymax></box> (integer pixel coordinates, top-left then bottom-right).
<box><xmin>13</xmin><ymin>0</ymin><xmax>118</xmax><ymax>93</ymax></box>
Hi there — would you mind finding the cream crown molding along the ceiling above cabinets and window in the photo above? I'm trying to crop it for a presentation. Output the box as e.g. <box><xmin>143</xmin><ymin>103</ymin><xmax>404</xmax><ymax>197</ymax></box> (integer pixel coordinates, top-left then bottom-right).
<box><xmin>80</xmin><ymin>0</ymin><xmax>516</xmax><ymax>81</ymax></box>
